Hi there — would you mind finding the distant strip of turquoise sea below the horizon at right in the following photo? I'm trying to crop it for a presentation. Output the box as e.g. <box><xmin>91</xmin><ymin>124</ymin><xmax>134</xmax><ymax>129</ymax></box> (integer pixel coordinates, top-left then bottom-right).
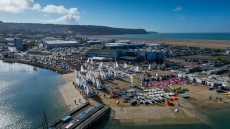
<box><xmin>104</xmin><ymin>33</ymin><xmax>230</xmax><ymax>40</ymax></box>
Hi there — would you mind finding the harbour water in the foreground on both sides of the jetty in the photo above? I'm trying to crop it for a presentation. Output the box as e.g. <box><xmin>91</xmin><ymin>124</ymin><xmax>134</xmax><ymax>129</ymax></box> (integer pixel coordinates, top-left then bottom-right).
<box><xmin>0</xmin><ymin>60</ymin><xmax>230</xmax><ymax>129</ymax></box>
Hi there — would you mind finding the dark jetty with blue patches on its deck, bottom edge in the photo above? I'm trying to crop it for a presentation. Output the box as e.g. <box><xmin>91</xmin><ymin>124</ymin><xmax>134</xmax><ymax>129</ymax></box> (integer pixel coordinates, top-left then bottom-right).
<box><xmin>49</xmin><ymin>102</ymin><xmax>110</xmax><ymax>129</ymax></box>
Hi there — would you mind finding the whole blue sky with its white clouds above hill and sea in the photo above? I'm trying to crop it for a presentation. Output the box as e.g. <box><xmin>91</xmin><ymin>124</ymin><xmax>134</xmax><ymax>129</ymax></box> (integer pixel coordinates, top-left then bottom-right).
<box><xmin>0</xmin><ymin>0</ymin><xmax>230</xmax><ymax>33</ymax></box>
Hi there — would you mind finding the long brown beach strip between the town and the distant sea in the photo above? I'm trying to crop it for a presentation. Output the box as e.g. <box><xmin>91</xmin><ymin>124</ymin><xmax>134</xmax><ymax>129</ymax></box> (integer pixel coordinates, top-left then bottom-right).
<box><xmin>91</xmin><ymin>36</ymin><xmax>230</xmax><ymax>49</ymax></box>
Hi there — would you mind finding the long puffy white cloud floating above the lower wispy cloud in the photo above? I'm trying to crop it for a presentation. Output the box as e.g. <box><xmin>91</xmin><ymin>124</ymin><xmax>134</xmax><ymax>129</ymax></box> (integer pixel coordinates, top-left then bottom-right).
<box><xmin>42</xmin><ymin>5</ymin><xmax>79</xmax><ymax>14</ymax></box>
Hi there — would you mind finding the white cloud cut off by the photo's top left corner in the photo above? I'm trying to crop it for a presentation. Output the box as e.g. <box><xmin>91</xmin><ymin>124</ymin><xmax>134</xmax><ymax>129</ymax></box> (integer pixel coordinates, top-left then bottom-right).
<box><xmin>0</xmin><ymin>0</ymin><xmax>34</xmax><ymax>13</ymax></box>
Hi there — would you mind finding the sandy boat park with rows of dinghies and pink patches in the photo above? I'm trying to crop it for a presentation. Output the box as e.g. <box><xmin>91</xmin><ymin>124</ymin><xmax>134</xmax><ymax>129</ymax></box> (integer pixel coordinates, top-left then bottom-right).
<box><xmin>64</xmin><ymin>58</ymin><xmax>230</xmax><ymax>123</ymax></box>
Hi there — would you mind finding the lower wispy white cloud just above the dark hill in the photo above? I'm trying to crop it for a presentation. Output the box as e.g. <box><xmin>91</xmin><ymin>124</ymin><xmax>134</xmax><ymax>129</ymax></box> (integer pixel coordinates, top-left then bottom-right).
<box><xmin>44</xmin><ymin>15</ymin><xmax>80</xmax><ymax>25</ymax></box>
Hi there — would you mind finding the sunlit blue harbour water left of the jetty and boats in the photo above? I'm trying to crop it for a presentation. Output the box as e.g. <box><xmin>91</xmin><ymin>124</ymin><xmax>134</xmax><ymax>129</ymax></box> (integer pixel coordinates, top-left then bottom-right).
<box><xmin>0</xmin><ymin>60</ymin><xmax>67</xmax><ymax>129</ymax></box>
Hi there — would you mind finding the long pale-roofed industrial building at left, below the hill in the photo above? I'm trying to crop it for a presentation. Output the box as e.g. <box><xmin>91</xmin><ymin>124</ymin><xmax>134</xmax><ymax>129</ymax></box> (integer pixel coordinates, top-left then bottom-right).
<box><xmin>43</xmin><ymin>40</ymin><xmax>79</xmax><ymax>49</ymax></box>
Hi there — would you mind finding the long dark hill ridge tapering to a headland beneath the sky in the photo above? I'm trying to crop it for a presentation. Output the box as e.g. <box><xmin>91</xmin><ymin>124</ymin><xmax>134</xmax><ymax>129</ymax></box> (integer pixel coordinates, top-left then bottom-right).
<box><xmin>0</xmin><ymin>22</ymin><xmax>148</xmax><ymax>35</ymax></box>
